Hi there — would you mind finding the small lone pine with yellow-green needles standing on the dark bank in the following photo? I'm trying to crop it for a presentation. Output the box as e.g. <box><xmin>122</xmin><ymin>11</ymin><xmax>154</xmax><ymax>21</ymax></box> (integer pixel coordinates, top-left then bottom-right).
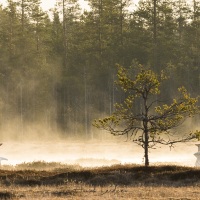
<box><xmin>94</xmin><ymin>65</ymin><xmax>200</xmax><ymax>166</ymax></box>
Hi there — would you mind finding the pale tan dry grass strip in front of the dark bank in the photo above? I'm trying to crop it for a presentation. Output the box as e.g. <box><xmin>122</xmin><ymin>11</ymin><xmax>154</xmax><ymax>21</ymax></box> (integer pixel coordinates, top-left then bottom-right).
<box><xmin>0</xmin><ymin>184</ymin><xmax>200</xmax><ymax>200</ymax></box>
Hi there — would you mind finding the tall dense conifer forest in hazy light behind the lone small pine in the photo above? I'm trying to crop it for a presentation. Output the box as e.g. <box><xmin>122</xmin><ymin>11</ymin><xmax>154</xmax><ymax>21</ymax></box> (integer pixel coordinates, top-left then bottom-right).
<box><xmin>0</xmin><ymin>0</ymin><xmax>200</xmax><ymax>140</ymax></box>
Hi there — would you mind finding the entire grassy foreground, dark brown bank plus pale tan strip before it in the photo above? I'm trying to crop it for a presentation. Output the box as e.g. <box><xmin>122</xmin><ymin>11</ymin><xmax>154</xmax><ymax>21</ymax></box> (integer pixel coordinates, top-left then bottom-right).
<box><xmin>0</xmin><ymin>162</ymin><xmax>200</xmax><ymax>200</ymax></box>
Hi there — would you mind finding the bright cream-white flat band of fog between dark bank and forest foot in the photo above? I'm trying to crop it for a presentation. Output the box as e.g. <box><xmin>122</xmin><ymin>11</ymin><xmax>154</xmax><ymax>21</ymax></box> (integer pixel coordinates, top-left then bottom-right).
<box><xmin>0</xmin><ymin>140</ymin><xmax>197</xmax><ymax>167</ymax></box>
